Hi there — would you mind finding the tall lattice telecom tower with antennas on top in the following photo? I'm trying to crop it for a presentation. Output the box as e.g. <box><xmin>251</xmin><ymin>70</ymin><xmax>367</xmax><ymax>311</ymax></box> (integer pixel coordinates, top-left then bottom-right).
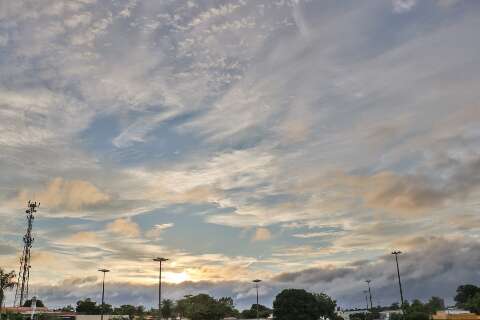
<box><xmin>14</xmin><ymin>201</ymin><xmax>40</xmax><ymax>307</ymax></box>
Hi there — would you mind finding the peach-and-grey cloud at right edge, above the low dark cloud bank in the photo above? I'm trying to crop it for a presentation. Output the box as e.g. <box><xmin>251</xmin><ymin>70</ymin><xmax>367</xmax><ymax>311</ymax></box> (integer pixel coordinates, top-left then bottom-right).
<box><xmin>318</xmin><ymin>158</ymin><xmax>480</xmax><ymax>216</ymax></box>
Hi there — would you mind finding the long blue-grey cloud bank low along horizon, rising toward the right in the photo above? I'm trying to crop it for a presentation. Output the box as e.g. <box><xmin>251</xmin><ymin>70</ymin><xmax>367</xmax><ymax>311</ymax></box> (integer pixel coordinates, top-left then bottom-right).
<box><xmin>27</xmin><ymin>237</ymin><xmax>480</xmax><ymax>308</ymax></box>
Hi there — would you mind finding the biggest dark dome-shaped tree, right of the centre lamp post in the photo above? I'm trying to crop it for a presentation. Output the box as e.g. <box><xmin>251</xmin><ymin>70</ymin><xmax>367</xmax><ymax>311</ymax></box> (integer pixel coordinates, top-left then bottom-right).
<box><xmin>273</xmin><ymin>289</ymin><xmax>320</xmax><ymax>320</ymax></box>
